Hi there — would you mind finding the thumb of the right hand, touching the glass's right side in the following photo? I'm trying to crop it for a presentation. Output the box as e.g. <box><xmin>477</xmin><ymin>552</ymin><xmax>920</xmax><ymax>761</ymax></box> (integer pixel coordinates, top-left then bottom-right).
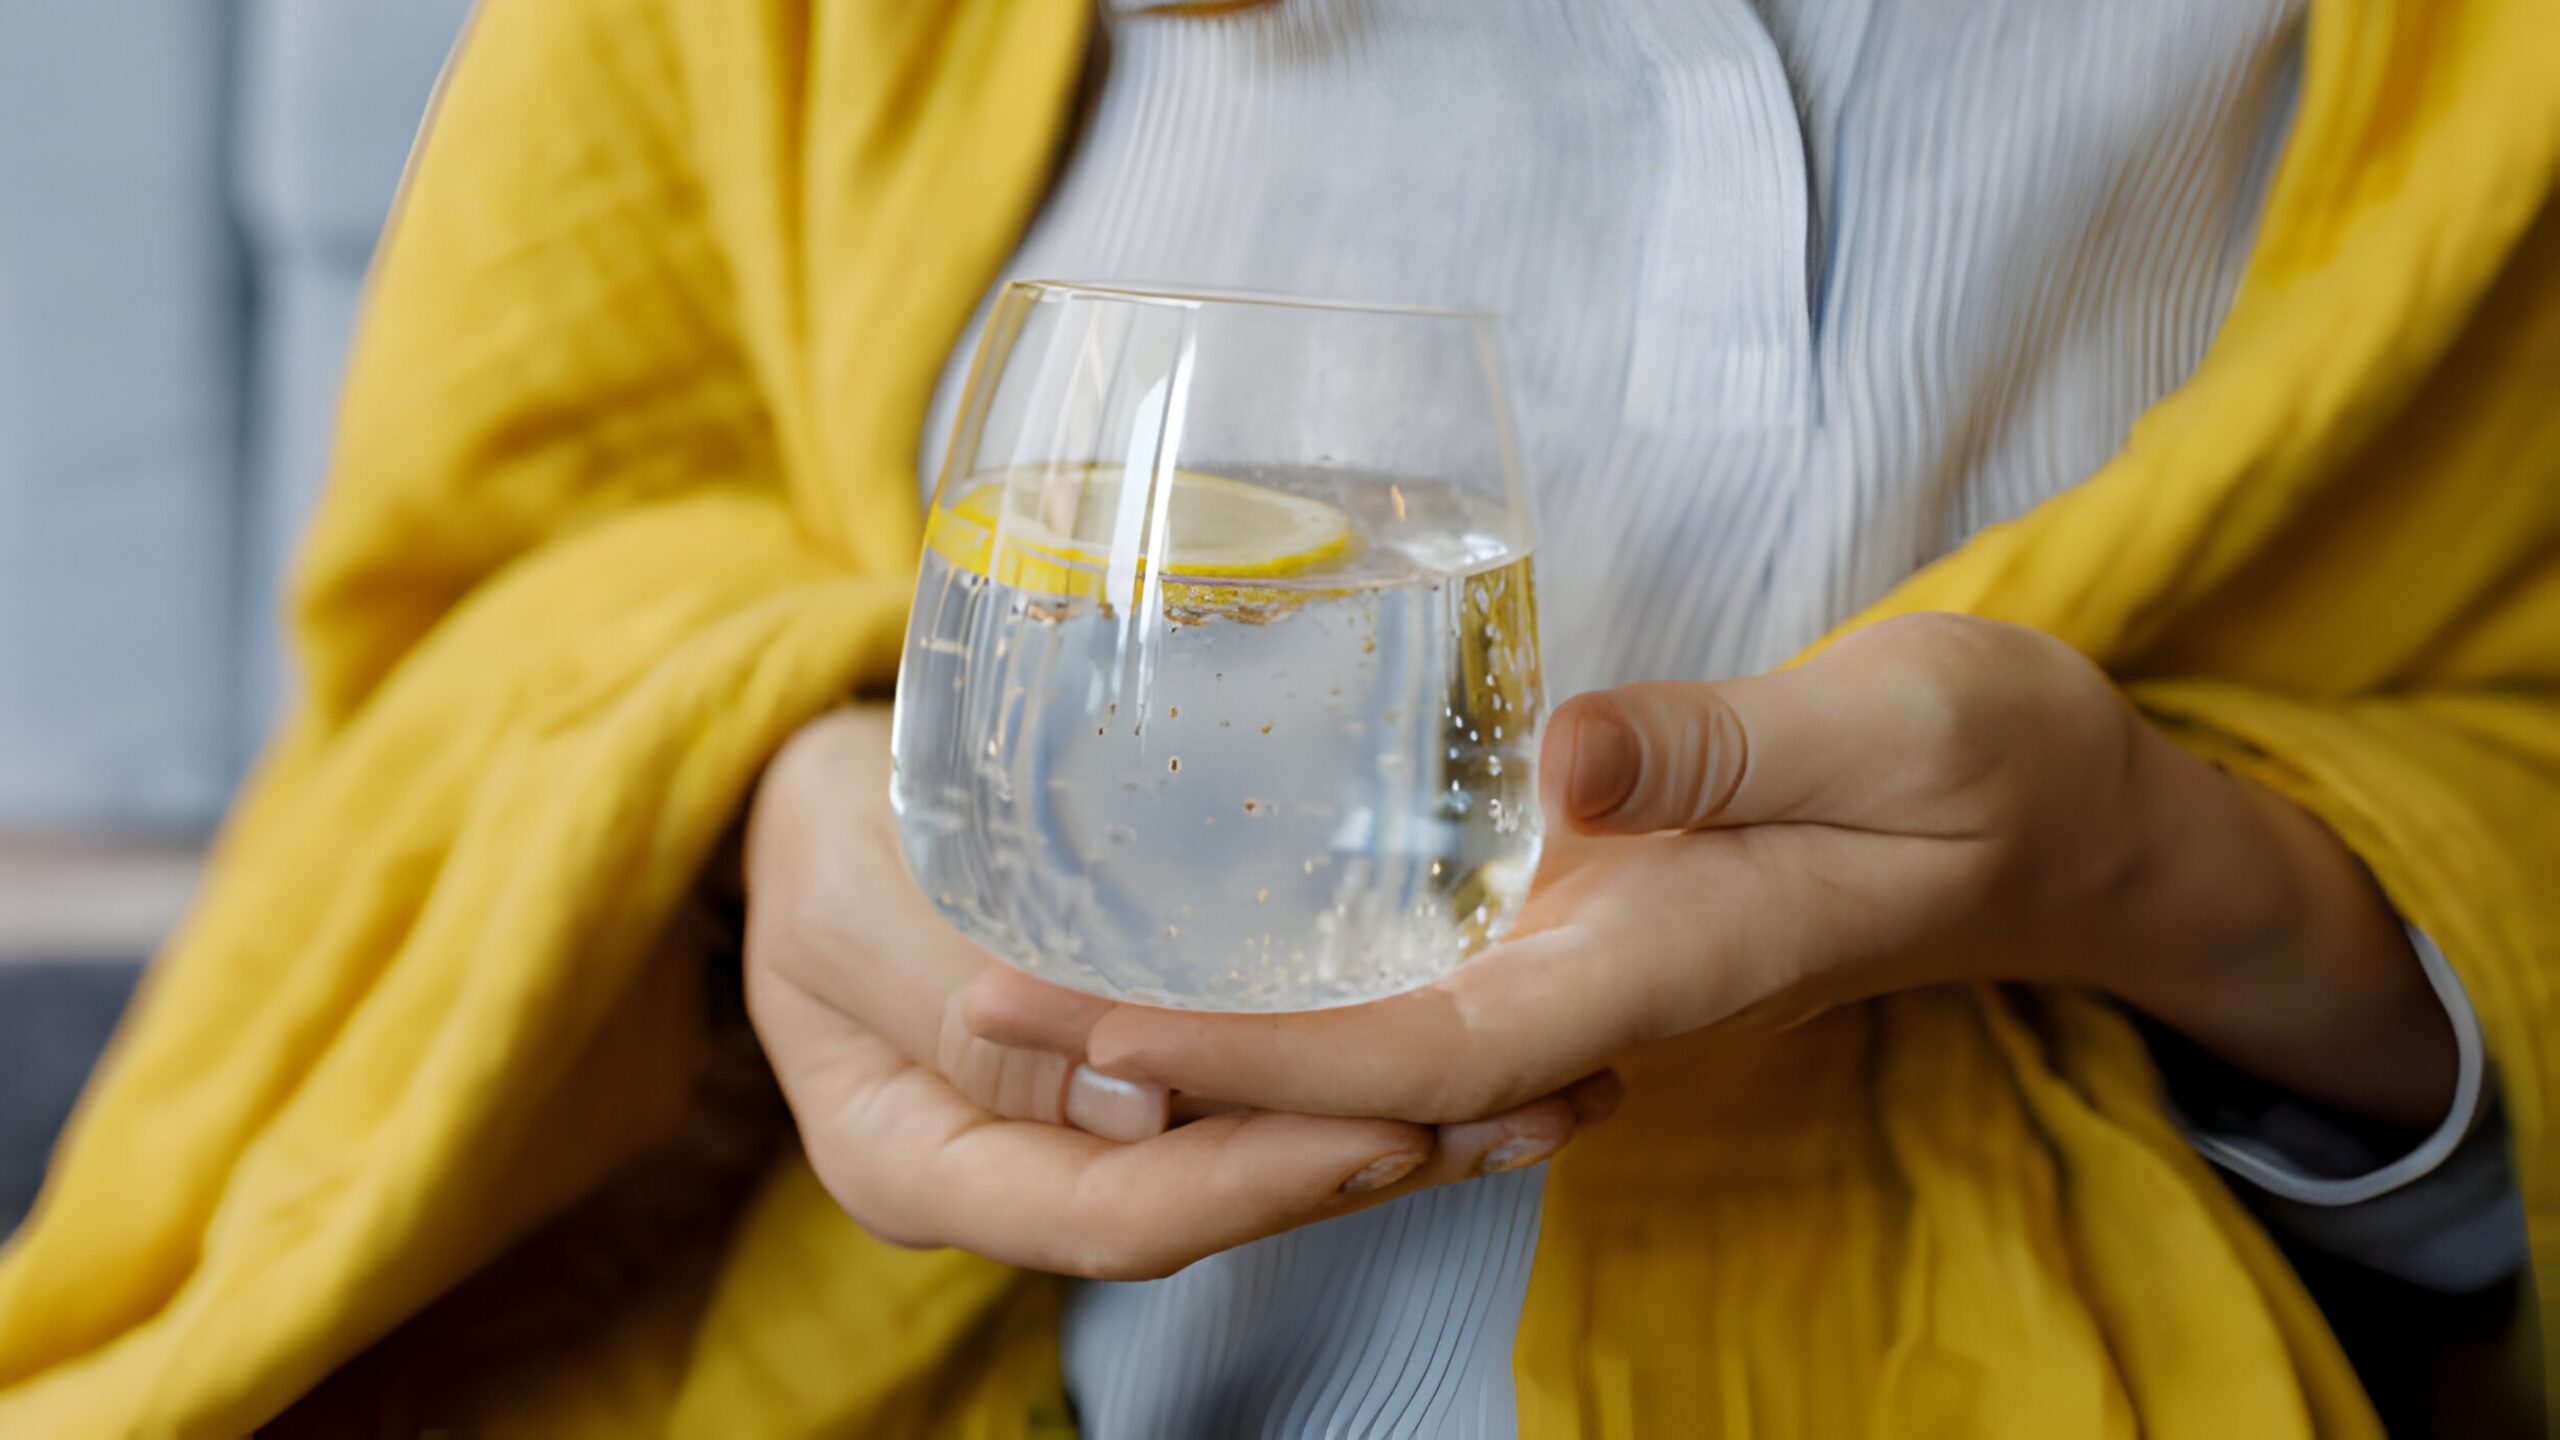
<box><xmin>1539</xmin><ymin>671</ymin><xmax>1843</xmax><ymax>835</ymax></box>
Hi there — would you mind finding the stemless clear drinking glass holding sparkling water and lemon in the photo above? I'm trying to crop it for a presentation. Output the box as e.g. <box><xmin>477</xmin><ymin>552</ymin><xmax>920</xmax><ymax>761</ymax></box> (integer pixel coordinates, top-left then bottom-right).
<box><xmin>891</xmin><ymin>282</ymin><xmax>1544</xmax><ymax>1010</ymax></box>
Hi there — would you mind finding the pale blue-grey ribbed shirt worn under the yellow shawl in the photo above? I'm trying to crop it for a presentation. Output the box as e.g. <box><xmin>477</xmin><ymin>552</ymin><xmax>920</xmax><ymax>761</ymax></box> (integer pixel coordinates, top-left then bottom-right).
<box><xmin>927</xmin><ymin>0</ymin><xmax>2299</xmax><ymax>1440</ymax></box>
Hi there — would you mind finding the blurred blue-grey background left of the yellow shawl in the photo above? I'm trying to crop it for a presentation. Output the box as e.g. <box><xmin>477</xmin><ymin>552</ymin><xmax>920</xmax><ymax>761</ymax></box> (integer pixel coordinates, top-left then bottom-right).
<box><xmin>0</xmin><ymin>0</ymin><xmax>468</xmax><ymax>1235</ymax></box>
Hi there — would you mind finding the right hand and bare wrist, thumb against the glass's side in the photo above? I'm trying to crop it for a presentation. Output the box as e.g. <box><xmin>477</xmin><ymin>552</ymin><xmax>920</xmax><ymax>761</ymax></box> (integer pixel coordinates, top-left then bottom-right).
<box><xmin>965</xmin><ymin>615</ymin><xmax>2455</xmax><ymax>1122</ymax></box>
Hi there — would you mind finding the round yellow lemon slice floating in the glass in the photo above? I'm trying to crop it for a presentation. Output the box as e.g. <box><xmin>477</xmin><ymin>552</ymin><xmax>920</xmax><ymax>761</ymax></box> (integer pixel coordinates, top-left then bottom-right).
<box><xmin>924</xmin><ymin>453</ymin><xmax>1354</xmax><ymax>607</ymax></box>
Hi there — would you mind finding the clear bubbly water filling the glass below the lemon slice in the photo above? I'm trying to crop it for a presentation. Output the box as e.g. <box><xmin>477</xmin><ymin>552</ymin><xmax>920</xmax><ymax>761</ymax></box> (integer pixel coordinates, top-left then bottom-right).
<box><xmin>893</xmin><ymin>471</ymin><xmax>1544</xmax><ymax>1010</ymax></box>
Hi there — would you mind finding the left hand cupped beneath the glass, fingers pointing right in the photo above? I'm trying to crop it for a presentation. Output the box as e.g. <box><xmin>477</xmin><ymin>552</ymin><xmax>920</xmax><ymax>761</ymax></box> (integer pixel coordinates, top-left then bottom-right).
<box><xmin>745</xmin><ymin>710</ymin><xmax>1618</xmax><ymax>1279</ymax></box>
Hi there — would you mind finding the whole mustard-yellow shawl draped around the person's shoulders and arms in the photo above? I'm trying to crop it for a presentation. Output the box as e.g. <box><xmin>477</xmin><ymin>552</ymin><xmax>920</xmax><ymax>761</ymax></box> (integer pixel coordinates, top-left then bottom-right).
<box><xmin>0</xmin><ymin>0</ymin><xmax>2560</xmax><ymax>1440</ymax></box>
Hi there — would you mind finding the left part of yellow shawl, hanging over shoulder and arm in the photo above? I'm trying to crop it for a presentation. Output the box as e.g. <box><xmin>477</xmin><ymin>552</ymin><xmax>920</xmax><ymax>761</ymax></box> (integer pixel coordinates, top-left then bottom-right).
<box><xmin>0</xmin><ymin>0</ymin><xmax>1085</xmax><ymax>1440</ymax></box>
